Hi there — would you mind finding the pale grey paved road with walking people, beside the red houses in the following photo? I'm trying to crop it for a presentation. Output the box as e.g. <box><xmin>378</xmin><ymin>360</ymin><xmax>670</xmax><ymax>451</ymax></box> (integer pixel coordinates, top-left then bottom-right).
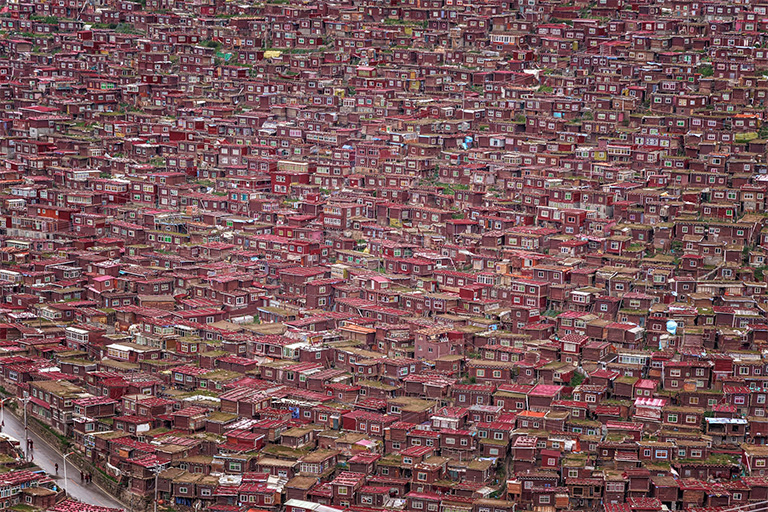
<box><xmin>3</xmin><ymin>406</ymin><xmax>125</xmax><ymax>509</ymax></box>
